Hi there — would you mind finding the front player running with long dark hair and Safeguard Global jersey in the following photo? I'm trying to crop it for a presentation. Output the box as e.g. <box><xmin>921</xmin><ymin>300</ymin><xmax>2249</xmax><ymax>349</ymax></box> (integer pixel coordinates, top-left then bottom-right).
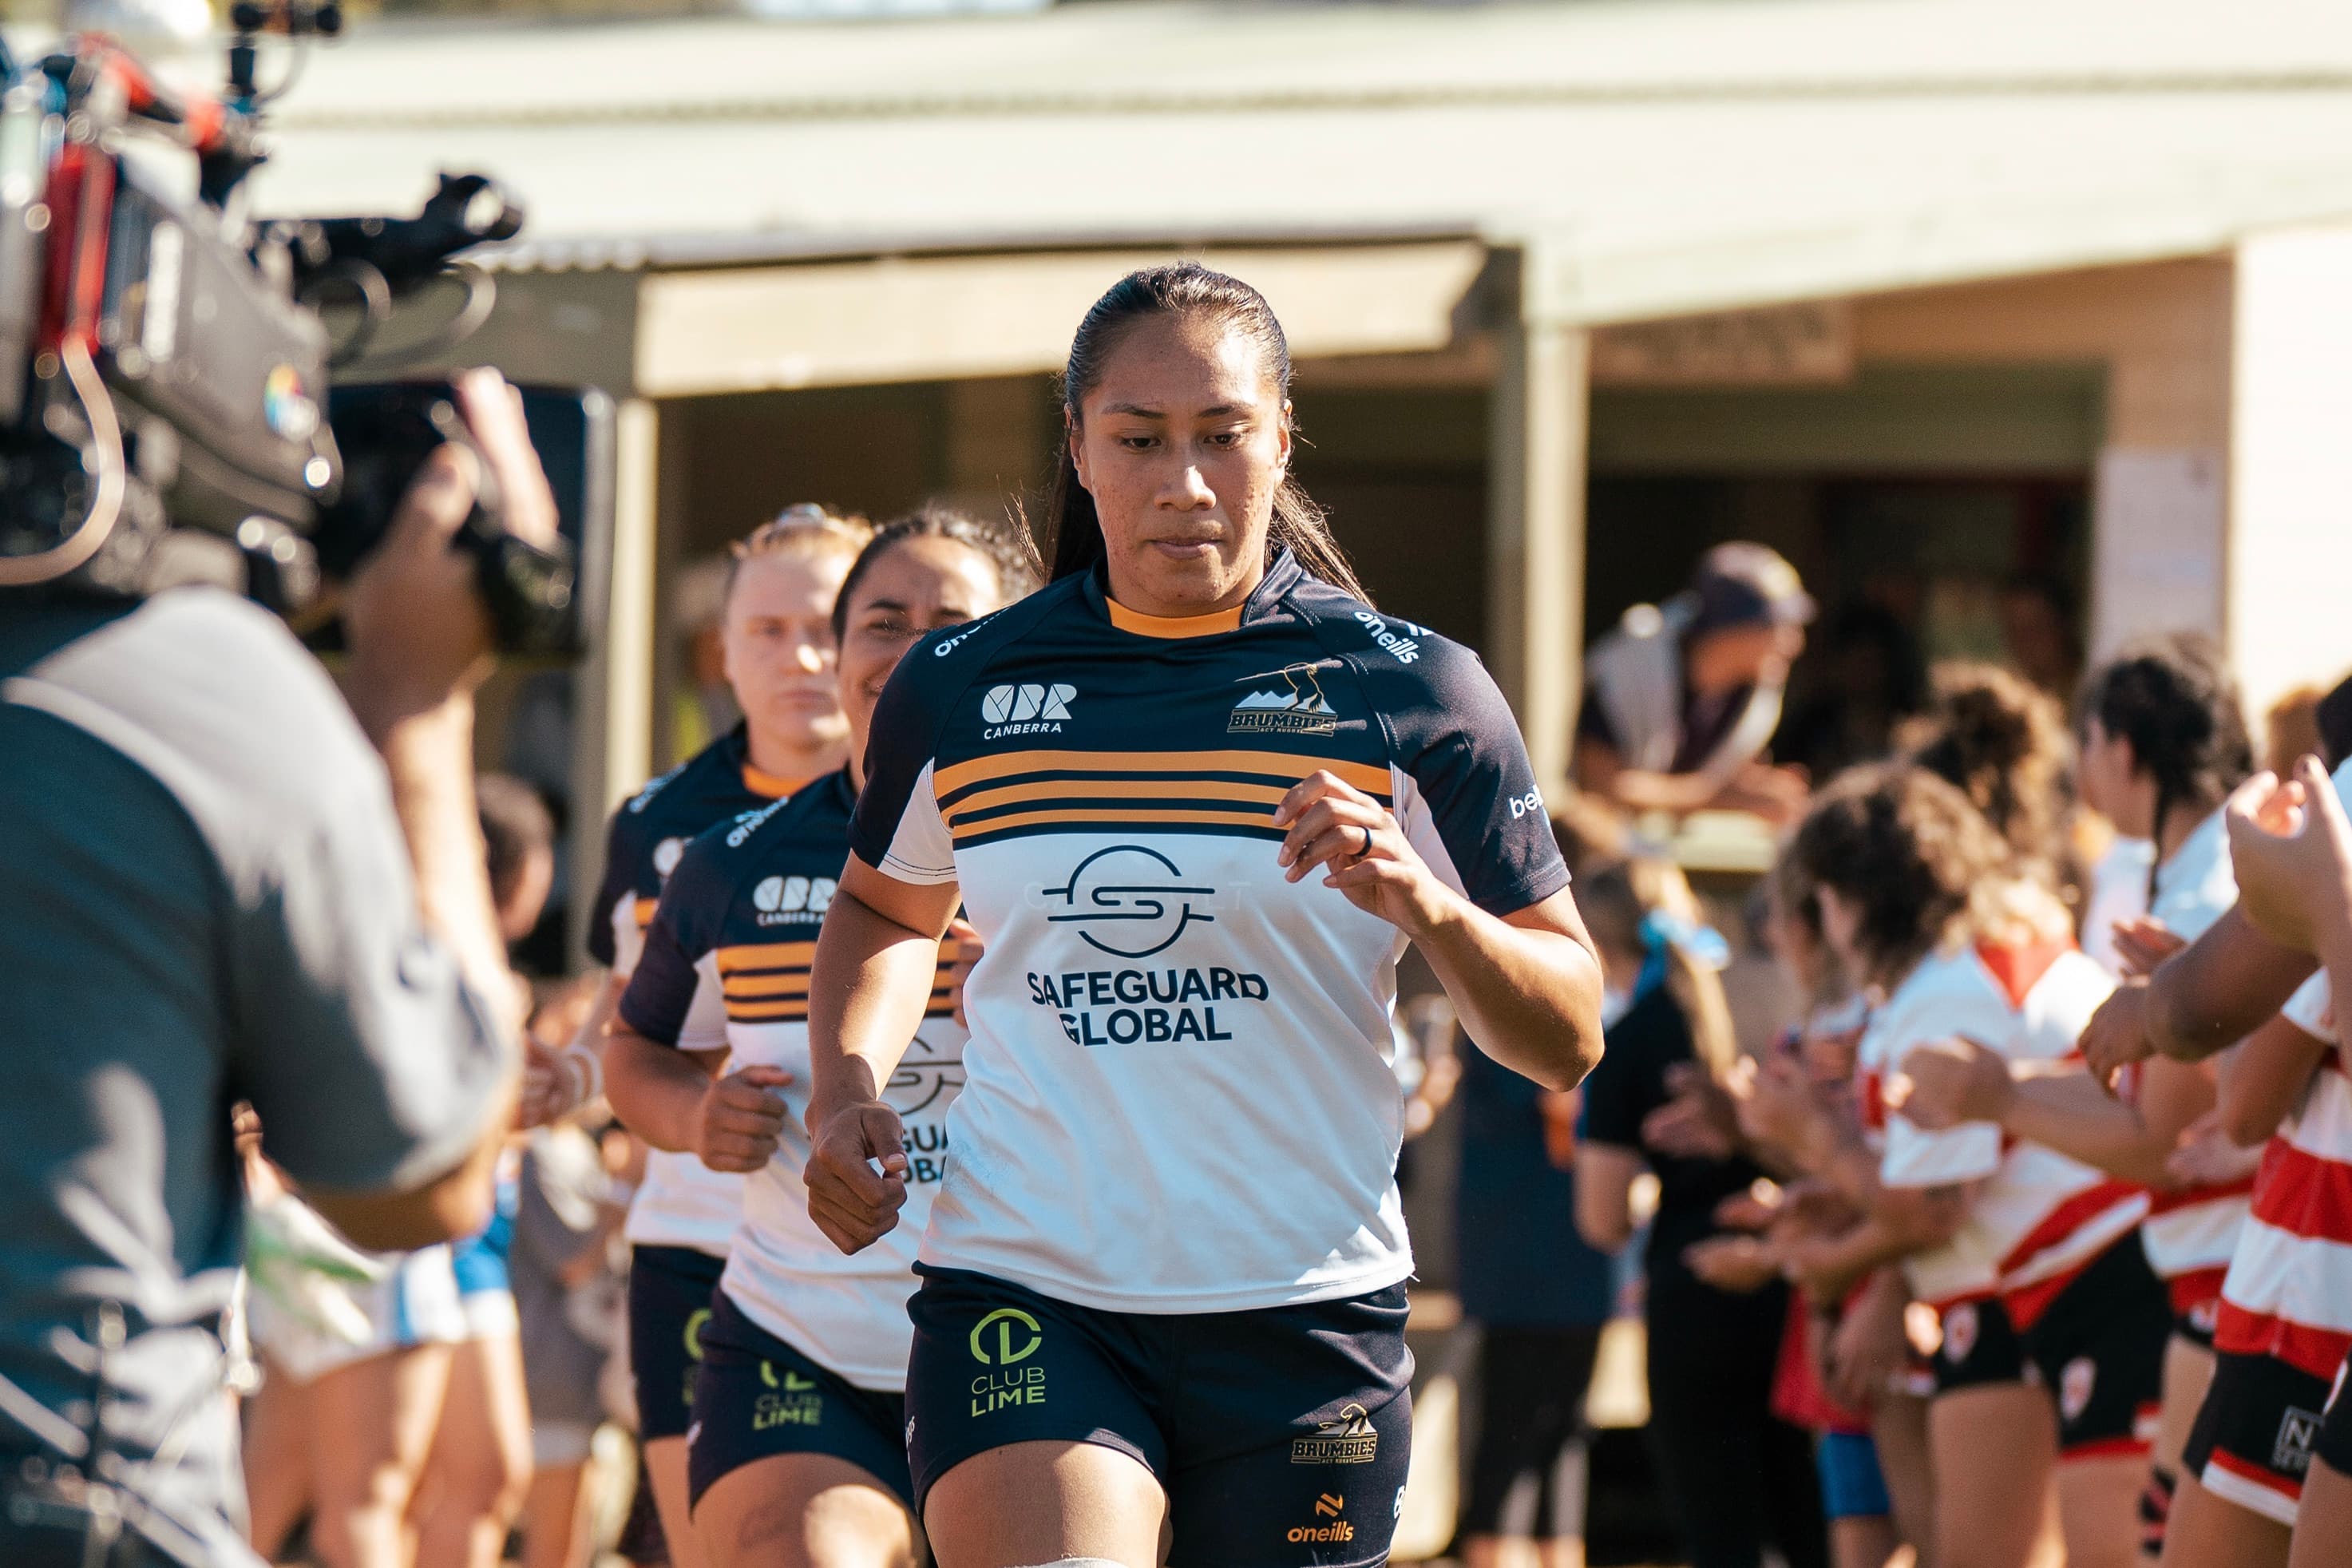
<box><xmin>809</xmin><ymin>266</ymin><xmax>1599</xmax><ymax>1568</ymax></box>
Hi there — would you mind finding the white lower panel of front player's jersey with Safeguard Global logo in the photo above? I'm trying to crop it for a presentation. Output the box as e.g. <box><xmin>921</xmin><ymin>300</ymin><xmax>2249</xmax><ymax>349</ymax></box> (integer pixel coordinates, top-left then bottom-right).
<box><xmin>922</xmin><ymin>827</ymin><xmax>1414</xmax><ymax>1312</ymax></box>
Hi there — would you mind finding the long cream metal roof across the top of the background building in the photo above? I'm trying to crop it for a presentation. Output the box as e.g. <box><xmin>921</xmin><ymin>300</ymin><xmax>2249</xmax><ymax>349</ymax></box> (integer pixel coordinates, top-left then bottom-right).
<box><xmin>27</xmin><ymin>0</ymin><xmax>2352</xmax><ymax>322</ymax></box>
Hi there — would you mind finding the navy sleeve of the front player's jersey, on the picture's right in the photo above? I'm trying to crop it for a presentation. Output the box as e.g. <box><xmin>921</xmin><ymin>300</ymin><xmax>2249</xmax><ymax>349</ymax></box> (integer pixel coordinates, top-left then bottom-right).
<box><xmin>1372</xmin><ymin>637</ymin><xmax>1569</xmax><ymax>914</ymax></box>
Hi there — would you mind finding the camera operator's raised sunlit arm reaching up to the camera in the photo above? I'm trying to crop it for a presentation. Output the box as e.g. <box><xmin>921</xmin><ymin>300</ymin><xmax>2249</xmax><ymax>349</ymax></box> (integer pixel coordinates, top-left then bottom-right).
<box><xmin>256</xmin><ymin>374</ymin><xmax>555</xmax><ymax>1249</ymax></box>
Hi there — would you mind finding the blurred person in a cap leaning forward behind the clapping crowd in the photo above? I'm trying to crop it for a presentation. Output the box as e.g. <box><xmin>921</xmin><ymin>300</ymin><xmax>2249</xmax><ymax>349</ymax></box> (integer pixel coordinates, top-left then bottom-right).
<box><xmin>1576</xmin><ymin>543</ymin><xmax>1813</xmax><ymax>821</ymax></box>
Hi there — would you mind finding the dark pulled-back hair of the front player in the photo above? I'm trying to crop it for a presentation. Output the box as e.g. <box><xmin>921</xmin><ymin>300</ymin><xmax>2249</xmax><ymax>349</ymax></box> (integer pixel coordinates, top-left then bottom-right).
<box><xmin>1039</xmin><ymin>261</ymin><xmax>1372</xmax><ymax>604</ymax></box>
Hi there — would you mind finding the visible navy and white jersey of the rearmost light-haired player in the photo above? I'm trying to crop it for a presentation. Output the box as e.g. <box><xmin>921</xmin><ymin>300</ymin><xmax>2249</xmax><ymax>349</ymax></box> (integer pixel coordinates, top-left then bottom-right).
<box><xmin>588</xmin><ymin>724</ymin><xmax>793</xmax><ymax>1257</ymax></box>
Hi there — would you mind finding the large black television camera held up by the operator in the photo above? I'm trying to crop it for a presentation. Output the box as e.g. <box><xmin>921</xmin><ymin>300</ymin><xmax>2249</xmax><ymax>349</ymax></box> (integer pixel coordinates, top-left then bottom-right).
<box><xmin>0</xmin><ymin>0</ymin><xmax>612</xmax><ymax>654</ymax></box>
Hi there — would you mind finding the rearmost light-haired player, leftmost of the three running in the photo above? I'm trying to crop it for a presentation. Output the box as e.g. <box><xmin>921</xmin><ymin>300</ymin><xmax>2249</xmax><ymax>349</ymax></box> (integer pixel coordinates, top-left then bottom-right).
<box><xmin>538</xmin><ymin>505</ymin><xmax>870</xmax><ymax>1568</ymax></box>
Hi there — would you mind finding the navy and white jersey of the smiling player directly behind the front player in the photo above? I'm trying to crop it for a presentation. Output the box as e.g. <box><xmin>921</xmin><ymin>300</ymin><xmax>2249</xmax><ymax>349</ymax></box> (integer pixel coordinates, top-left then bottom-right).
<box><xmin>621</xmin><ymin>771</ymin><xmax>964</xmax><ymax>1392</ymax></box>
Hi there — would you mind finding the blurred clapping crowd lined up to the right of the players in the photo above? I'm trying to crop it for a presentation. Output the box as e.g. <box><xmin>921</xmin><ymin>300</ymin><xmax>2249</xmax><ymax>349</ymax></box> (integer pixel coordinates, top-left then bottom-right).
<box><xmin>1459</xmin><ymin>545</ymin><xmax>2352</xmax><ymax>1568</ymax></box>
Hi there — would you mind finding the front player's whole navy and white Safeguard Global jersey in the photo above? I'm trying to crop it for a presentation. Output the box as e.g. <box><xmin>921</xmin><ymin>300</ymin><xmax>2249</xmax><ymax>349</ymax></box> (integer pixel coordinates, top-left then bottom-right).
<box><xmin>851</xmin><ymin>552</ymin><xmax>1569</xmax><ymax>1312</ymax></box>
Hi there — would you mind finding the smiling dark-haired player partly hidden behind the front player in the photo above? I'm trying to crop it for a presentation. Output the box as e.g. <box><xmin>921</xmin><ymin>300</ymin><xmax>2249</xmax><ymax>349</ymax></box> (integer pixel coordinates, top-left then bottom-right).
<box><xmin>612</xmin><ymin>510</ymin><xmax>1037</xmax><ymax>1568</ymax></box>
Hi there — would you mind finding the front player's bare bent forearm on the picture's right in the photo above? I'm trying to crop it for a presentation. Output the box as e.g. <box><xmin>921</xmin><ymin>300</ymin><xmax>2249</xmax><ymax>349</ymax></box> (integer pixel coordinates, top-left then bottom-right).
<box><xmin>1414</xmin><ymin>901</ymin><xmax>1602</xmax><ymax>1088</ymax></box>
